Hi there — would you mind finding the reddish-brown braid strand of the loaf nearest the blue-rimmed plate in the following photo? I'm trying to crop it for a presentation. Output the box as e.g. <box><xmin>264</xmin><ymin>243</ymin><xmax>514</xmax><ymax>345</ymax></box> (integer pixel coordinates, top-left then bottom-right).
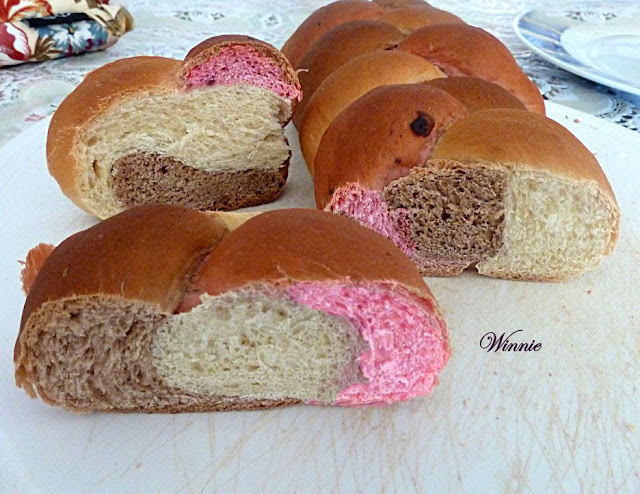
<box><xmin>398</xmin><ymin>24</ymin><xmax>545</xmax><ymax>115</ymax></box>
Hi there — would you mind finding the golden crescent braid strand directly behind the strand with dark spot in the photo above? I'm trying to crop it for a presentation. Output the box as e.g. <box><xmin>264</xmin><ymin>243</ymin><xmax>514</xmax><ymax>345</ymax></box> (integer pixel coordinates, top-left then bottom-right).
<box><xmin>300</xmin><ymin>51</ymin><xmax>444</xmax><ymax>174</ymax></box>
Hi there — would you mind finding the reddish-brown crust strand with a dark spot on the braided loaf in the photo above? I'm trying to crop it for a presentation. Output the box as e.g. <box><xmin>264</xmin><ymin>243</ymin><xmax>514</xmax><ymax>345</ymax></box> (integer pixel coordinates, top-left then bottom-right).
<box><xmin>314</xmin><ymin>84</ymin><xmax>467</xmax><ymax>209</ymax></box>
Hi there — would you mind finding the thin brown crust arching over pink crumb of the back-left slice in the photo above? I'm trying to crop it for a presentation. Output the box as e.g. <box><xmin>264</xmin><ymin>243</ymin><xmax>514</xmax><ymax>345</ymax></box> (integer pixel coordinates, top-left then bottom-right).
<box><xmin>176</xmin><ymin>34</ymin><xmax>300</xmax><ymax>112</ymax></box>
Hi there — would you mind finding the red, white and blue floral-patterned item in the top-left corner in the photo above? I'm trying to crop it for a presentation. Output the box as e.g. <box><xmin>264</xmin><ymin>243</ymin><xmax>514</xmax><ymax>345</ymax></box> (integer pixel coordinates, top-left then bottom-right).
<box><xmin>0</xmin><ymin>0</ymin><xmax>133</xmax><ymax>67</ymax></box>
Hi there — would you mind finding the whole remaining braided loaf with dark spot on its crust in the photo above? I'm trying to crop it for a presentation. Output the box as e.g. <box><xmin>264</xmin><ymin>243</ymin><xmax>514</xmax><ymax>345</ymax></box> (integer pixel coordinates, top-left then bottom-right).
<box><xmin>287</xmin><ymin>0</ymin><xmax>619</xmax><ymax>280</ymax></box>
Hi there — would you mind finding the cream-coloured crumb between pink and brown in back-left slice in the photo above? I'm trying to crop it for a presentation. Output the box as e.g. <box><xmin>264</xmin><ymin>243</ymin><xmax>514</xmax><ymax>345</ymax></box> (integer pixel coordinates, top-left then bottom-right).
<box><xmin>76</xmin><ymin>84</ymin><xmax>291</xmax><ymax>217</ymax></box>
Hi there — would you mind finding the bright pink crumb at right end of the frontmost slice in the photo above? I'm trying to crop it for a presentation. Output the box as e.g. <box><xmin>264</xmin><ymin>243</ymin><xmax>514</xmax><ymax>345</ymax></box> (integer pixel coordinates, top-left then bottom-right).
<box><xmin>288</xmin><ymin>282</ymin><xmax>450</xmax><ymax>406</ymax></box>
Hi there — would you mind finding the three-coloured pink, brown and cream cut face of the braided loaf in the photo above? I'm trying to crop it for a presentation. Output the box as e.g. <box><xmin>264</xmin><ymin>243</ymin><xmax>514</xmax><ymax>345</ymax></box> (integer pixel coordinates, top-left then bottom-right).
<box><xmin>330</xmin><ymin>164</ymin><xmax>617</xmax><ymax>281</ymax></box>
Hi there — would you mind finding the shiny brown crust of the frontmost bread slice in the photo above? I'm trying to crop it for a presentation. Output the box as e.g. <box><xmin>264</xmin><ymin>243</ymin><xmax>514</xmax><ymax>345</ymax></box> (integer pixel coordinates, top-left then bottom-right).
<box><xmin>14</xmin><ymin>204</ymin><xmax>446</xmax><ymax>413</ymax></box>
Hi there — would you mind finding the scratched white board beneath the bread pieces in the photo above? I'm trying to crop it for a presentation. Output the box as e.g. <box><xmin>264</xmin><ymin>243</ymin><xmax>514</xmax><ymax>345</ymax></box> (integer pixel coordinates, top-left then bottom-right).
<box><xmin>0</xmin><ymin>104</ymin><xmax>640</xmax><ymax>494</ymax></box>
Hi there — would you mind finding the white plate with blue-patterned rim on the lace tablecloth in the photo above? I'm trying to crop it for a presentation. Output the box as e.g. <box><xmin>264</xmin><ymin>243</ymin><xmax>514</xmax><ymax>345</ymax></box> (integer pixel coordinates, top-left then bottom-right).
<box><xmin>513</xmin><ymin>2</ymin><xmax>640</xmax><ymax>95</ymax></box>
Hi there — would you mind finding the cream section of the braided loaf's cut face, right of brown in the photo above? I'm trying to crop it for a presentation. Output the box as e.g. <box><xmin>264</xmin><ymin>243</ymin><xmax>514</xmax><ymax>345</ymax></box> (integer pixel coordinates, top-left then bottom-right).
<box><xmin>477</xmin><ymin>170</ymin><xmax>618</xmax><ymax>280</ymax></box>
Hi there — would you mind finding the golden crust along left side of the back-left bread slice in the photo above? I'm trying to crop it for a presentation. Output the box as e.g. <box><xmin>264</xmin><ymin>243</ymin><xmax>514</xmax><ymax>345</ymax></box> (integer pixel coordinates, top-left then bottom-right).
<box><xmin>47</xmin><ymin>57</ymin><xmax>182</xmax><ymax>212</ymax></box>
